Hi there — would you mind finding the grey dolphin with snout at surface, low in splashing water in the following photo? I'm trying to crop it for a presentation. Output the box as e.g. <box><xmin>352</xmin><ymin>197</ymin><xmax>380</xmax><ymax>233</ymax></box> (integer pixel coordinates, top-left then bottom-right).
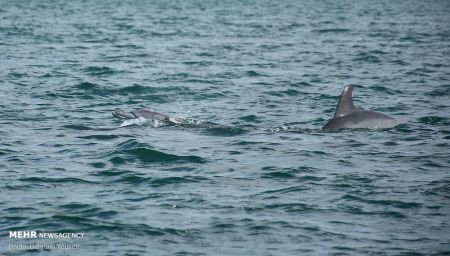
<box><xmin>112</xmin><ymin>108</ymin><xmax>184</xmax><ymax>125</ymax></box>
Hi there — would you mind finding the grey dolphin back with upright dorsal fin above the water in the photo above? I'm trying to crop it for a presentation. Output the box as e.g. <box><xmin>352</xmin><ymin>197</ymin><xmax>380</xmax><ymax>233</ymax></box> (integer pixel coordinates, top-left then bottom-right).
<box><xmin>322</xmin><ymin>85</ymin><xmax>400</xmax><ymax>130</ymax></box>
